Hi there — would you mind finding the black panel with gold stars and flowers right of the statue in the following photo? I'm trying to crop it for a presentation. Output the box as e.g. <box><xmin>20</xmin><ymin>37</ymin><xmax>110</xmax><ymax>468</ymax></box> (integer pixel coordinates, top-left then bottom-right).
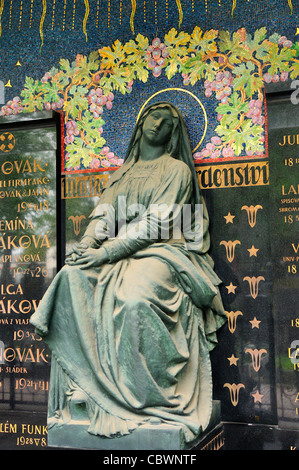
<box><xmin>202</xmin><ymin>158</ymin><xmax>277</xmax><ymax>424</ymax></box>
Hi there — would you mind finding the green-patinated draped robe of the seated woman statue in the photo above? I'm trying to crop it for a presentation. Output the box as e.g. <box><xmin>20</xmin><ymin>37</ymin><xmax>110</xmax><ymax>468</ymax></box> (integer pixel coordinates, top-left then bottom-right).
<box><xmin>30</xmin><ymin>155</ymin><xmax>226</xmax><ymax>442</ymax></box>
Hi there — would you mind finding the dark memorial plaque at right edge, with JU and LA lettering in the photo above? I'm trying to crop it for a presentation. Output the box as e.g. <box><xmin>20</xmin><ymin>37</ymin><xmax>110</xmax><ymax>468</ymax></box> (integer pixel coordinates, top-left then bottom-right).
<box><xmin>268</xmin><ymin>93</ymin><xmax>299</xmax><ymax>430</ymax></box>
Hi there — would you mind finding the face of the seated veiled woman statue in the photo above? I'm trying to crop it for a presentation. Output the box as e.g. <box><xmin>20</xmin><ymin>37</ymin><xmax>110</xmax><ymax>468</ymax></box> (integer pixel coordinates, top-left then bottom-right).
<box><xmin>142</xmin><ymin>108</ymin><xmax>173</xmax><ymax>146</ymax></box>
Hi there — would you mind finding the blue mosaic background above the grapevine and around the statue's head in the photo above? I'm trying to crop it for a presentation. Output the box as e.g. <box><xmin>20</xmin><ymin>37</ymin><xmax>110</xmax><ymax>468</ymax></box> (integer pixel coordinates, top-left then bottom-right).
<box><xmin>0</xmin><ymin>0</ymin><xmax>299</xmax><ymax>162</ymax></box>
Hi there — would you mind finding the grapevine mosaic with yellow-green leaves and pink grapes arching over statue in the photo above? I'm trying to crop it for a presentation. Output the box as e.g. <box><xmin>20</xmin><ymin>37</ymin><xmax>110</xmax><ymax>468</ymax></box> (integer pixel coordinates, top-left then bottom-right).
<box><xmin>0</xmin><ymin>26</ymin><xmax>299</xmax><ymax>170</ymax></box>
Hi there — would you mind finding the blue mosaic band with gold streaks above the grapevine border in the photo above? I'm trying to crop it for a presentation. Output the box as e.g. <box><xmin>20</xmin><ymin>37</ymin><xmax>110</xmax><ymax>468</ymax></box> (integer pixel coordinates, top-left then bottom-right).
<box><xmin>0</xmin><ymin>0</ymin><xmax>299</xmax><ymax>89</ymax></box>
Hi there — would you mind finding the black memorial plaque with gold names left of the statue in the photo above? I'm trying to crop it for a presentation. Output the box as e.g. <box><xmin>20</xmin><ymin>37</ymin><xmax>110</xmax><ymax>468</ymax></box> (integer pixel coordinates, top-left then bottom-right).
<box><xmin>0</xmin><ymin>112</ymin><xmax>61</xmax><ymax>448</ymax></box>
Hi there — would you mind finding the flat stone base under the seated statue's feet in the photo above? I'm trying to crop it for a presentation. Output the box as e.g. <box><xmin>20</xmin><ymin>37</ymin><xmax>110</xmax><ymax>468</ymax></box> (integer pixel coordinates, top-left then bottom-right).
<box><xmin>48</xmin><ymin>401</ymin><xmax>223</xmax><ymax>450</ymax></box>
